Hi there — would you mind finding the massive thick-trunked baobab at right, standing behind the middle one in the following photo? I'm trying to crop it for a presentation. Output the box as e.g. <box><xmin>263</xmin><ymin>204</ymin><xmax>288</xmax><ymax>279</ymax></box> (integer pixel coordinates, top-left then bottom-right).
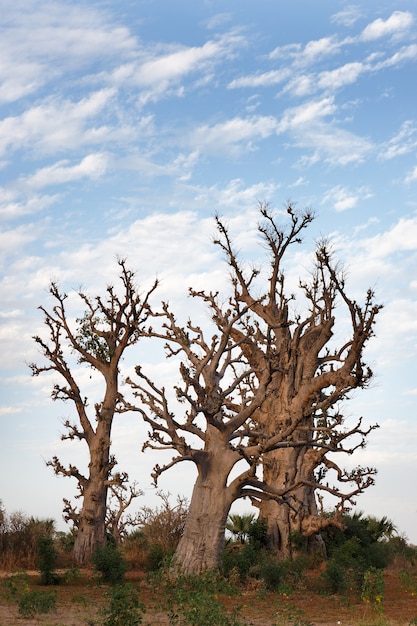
<box><xmin>216</xmin><ymin>204</ymin><xmax>381</xmax><ymax>557</ymax></box>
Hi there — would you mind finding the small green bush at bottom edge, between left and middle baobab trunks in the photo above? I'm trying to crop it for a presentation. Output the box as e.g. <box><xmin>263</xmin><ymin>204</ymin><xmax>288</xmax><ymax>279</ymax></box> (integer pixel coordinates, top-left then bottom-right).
<box><xmin>100</xmin><ymin>584</ymin><xmax>145</xmax><ymax>626</ymax></box>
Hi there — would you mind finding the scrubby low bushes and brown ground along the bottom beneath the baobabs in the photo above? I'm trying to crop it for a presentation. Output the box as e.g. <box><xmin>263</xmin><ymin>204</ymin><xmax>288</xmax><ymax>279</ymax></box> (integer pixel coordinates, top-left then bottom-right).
<box><xmin>0</xmin><ymin>495</ymin><xmax>417</xmax><ymax>626</ymax></box>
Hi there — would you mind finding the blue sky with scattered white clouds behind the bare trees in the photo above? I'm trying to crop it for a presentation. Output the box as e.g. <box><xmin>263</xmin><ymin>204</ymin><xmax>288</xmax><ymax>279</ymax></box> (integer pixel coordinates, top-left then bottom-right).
<box><xmin>0</xmin><ymin>0</ymin><xmax>417</xmax><ymax>543</ymax></box>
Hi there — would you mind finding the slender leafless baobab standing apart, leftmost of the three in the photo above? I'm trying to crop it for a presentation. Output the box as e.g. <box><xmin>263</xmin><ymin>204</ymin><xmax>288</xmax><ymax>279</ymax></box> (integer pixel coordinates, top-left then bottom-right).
<box><xmin>30</xmin><ymin>260</ymin><xmax>157</xmax><ymax>564</ymax></box>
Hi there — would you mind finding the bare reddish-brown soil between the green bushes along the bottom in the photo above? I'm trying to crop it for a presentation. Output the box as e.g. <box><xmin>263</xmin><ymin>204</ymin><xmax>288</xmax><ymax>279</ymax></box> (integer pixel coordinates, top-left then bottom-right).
<box><xmin>0</xmin><ymin>569</ymin><xmax>417</xmax><ymax>626</ymax></box>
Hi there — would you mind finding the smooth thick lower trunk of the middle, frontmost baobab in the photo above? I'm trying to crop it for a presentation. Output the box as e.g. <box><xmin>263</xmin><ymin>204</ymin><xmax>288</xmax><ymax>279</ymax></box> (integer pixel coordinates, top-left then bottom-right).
<box><xmin>174</xmin><ymin>450</ymin><xmax>235</xmax><ymax>574</ymax></box>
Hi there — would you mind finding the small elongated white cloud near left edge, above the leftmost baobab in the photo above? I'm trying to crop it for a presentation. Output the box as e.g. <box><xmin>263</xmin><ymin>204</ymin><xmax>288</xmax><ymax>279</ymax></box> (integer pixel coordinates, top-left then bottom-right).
<box><xmin>25</xmin><ymin>153</ymin><xmax>108</xmax><ymax>188</ymax></box>
